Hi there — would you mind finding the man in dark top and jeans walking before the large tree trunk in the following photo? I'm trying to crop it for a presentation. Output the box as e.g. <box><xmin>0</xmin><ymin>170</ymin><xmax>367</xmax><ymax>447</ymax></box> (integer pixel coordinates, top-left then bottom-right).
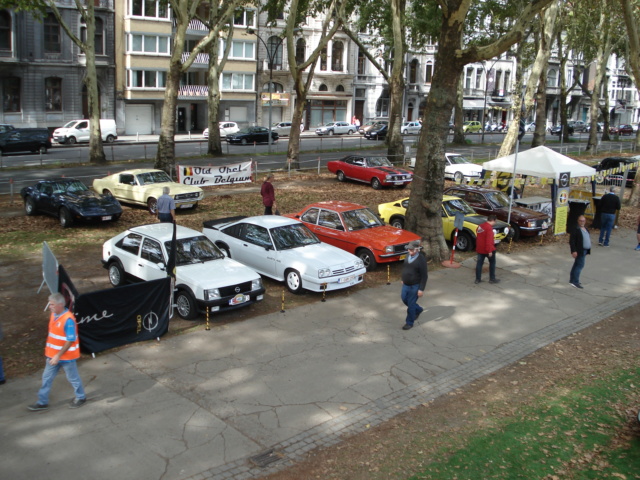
<box><xmin>400</xmin><ymin>240</ymin><xmax>429</xmax><ymax>330</ymax></box>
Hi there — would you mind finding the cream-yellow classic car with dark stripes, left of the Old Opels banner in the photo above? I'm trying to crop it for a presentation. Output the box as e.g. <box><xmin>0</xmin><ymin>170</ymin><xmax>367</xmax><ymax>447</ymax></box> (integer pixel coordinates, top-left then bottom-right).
<box><xmin>93</xmin><ymin>168</ymin><xmax>204</xmax><ymax>214</ymax></box>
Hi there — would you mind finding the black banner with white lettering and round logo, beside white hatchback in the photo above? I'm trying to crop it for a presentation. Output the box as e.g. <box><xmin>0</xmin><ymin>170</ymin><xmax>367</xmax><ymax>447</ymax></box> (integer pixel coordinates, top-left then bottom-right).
<box><xmin>74</xmin><ymin>277</ymin><xmax>171</xmax><ymax>353</ymax></box>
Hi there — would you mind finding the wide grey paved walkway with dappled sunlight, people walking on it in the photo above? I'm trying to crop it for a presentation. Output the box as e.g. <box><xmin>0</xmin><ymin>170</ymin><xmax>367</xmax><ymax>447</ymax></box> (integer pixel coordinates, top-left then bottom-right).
<box><xmin>0</xmin><ymin>229</ymin><xmax>640</xmax><ymax>480</ymax></box>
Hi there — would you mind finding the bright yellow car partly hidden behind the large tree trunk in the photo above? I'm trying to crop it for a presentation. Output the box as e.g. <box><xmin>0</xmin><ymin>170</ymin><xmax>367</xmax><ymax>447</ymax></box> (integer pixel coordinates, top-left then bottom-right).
<box><xmin>378</xmin><ymin>195</ymin><xmax>509</xmax><ymax>252</ymax></box>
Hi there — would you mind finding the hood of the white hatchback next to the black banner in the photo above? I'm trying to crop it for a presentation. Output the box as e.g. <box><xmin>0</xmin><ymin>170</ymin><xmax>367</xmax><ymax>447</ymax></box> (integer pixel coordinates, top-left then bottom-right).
<box><xmin>176</xmin><ymin>257</ymin><xmax>260</xmax><ymax>290</ymax></box>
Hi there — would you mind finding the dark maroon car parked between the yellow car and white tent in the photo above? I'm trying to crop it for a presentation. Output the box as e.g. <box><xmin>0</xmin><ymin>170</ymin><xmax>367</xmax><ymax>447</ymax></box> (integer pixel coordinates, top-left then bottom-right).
<box><xmin>444</xmin><ymin>185</ymin><xmax>551</xmax><ymax>241</ymax></box>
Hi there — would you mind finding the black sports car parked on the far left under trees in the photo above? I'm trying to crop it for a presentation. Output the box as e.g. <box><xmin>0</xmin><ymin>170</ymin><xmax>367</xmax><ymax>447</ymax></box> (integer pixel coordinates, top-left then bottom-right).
<box><xmin>20</xmin><ymin>177</ymin><xmax>122</xmax><ymax>228</ymax></box>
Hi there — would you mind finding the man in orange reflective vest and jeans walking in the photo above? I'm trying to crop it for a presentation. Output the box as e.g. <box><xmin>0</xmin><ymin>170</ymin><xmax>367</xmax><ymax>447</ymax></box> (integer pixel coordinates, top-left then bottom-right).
<box><xmin>28</xmin><ymin>293</ymin><xmax>87</xmax><ymax>412</ymax></box>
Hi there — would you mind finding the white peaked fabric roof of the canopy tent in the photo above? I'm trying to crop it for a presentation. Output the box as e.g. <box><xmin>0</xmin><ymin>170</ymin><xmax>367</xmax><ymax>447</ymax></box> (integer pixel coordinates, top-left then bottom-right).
<box><xmin>482</xmin><ymin>146</ymin><xmax>596</xmax><ymax>181</ymax></box>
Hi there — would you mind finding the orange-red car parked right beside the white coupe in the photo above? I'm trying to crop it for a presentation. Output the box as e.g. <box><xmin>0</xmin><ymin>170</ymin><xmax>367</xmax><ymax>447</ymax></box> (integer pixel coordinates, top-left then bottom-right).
<box><xmin>286</xmin><ymin>201</ymin><xmax>420</xmax><ymax>271</ymax></box>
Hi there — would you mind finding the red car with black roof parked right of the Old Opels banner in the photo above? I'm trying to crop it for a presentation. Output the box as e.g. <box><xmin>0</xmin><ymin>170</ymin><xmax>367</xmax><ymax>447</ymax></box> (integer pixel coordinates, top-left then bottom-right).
<box><xmin>327</xmin><ymin>155</ymin><xmax>413</xmax><ymax>190</ymax></box>
